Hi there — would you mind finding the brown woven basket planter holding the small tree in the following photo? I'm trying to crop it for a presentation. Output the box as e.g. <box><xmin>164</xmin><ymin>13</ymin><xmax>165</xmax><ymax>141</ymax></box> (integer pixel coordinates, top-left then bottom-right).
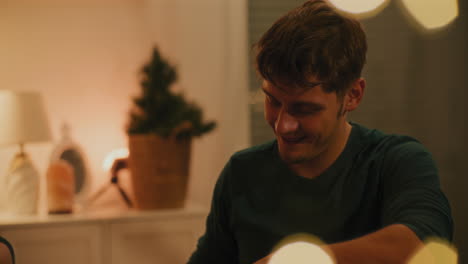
<box><xmin>129</xmin><ymin>134</ymin><xmax>191</xmax><ymax>210</ymax></box>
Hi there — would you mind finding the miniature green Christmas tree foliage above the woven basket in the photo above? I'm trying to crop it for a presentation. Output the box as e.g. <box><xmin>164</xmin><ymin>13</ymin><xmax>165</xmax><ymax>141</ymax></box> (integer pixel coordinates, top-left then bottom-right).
<box><xmin>127</xmin><ymin>47</ymin><xmax>216</xmax><ymax>139</ymax></box>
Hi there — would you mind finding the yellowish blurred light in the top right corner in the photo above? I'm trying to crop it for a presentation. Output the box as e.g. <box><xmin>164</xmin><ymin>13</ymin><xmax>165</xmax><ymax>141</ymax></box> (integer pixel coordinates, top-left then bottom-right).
<box><xmin>402</xmin><ymin>0</ymin><xmax>458</xmax><ymax>29</ymax></box>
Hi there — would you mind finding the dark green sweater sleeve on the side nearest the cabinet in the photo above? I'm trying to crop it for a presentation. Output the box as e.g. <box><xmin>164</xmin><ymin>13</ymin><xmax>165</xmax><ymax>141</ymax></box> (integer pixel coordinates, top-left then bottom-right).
<box><xmin>188</xmin><ymin>159</ymin><xmax>238</xmax><ymax>264</ymax></box>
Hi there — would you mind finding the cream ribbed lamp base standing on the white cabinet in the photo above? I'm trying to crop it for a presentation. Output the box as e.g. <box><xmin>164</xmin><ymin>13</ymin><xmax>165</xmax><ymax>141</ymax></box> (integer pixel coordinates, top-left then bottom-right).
<box><xmin>5</xmin><ymin>152</ymin><xmax>39</xmax><ymax>215</ymax></box>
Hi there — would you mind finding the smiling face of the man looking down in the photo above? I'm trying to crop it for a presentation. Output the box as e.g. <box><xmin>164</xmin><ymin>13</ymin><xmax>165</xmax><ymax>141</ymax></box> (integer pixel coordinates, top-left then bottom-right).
<box><xmin>262</xmin><ymin>81</ymin><xmax>346</xmax><ymax>164</ymax></box>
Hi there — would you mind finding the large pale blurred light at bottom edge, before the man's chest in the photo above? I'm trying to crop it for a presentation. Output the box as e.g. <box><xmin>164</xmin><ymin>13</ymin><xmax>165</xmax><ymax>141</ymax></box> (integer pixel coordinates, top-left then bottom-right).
<box><xmin>268</xmin><ymin>241</ymin><xmax>333</xmax><ymax>264</ymax></box>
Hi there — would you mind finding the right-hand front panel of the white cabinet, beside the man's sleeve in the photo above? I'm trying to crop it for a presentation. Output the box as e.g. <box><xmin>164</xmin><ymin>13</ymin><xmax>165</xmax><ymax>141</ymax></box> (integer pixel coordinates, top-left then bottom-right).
<box><xmin>111</xmin><ymin>217</ymin><xmax>204</xmax><ymax>264</ymax></box>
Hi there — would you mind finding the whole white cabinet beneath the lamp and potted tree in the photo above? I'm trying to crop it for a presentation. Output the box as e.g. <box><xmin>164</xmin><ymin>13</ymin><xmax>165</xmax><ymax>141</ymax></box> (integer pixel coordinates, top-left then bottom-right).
<box><xmin>0</xmin><ymin>209</ymin><xmax>207</xmax><ymax>264</ymax></box>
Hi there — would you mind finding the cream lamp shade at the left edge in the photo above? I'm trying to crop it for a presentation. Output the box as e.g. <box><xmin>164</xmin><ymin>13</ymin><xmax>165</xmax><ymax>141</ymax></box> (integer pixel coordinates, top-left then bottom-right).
<box><xmin>0</xmin><ymin>90</ymin><xmax>52</xmax><ymax>146</ymax></box>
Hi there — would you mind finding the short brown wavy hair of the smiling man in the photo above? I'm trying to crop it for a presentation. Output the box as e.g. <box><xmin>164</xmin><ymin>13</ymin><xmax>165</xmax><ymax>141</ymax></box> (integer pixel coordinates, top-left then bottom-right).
<box><xmin>255</xmin><ymin>0</ymin><xmax>367</xmax><ymax>95</ymax></box>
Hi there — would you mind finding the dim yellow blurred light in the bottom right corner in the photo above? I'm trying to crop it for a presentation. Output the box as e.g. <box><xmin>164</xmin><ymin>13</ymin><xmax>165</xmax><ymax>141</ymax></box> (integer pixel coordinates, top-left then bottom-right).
<box><xmin>408</xmin><ymin>239</ymin><xmax>458</xmax><ymax>264</ymax></box>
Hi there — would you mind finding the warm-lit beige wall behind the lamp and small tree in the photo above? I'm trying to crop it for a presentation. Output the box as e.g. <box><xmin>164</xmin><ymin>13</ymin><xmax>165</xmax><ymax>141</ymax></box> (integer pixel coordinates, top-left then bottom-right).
<box><xmin>0</xmin><ymin>0</ymin><xmax>249</xmax><ymax>210</ymax></box>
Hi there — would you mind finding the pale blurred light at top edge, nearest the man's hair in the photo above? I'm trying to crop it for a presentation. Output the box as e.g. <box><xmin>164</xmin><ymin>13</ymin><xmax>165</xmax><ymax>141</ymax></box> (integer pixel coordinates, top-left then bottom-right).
<box><xmin>330</xmin><ymin>0</ymin><xmax>390</xmax><ymax>17</ymax></box>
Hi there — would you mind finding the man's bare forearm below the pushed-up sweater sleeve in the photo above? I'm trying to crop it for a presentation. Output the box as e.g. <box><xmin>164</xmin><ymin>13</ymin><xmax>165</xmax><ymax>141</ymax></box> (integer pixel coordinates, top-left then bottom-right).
<box><xmin>254</xmin><ymin>224</ymin><xmax>423</xmax><ymax>264</ymax></box>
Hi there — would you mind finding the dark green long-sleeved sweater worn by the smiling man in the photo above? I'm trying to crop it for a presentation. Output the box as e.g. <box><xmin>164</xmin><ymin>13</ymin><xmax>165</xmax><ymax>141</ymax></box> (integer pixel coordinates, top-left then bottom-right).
<box><xmin>189</xmin><ymin>124</ymin><xmax>453</xmax><ymax>264</ymax></box>
